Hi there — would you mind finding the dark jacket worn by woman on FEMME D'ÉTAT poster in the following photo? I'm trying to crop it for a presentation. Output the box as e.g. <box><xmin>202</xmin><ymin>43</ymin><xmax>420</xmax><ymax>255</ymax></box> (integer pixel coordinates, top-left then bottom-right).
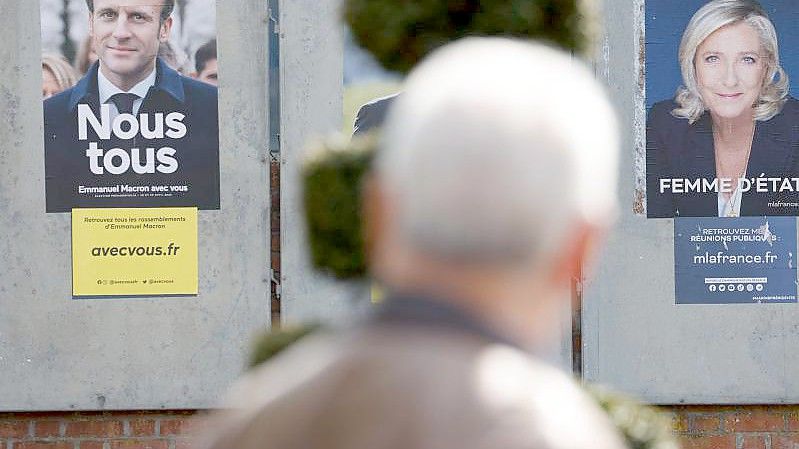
<box><xmin>646</xmin><ymin>98</ymin><xmax>799</xmax><ymax>218</ymax></box>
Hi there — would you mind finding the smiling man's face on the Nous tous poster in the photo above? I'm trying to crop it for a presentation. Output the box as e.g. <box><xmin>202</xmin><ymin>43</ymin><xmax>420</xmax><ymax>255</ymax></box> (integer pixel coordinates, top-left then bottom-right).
<box><xmin>89</xmin><ymin>0</ymin><xmax>172</xmax><ymax>91</ymax></box>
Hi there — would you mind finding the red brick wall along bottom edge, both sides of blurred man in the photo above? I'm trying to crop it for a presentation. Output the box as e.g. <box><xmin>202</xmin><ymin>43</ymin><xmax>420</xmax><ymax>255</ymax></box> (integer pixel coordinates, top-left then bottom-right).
<box><xmin>0</xmin><ymin>405</ymin><xmax>799</xmax><ymax>449</ymax></box>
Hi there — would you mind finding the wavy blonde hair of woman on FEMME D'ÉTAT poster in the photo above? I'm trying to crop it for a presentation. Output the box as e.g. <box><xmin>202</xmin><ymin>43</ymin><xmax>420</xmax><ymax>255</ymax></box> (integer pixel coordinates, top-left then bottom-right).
<box><xmin>672</xmin><ymin>0</ymin><xmax>788</xmax><ymax>123</ymax></box>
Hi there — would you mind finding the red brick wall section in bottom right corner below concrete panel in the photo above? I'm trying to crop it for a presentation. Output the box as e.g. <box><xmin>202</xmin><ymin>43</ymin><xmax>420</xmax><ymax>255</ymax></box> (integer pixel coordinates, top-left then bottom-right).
<box><xmin>665</xmin><ymin>405</ymin><xmax>799</xmax><ymax>449</ymax></box>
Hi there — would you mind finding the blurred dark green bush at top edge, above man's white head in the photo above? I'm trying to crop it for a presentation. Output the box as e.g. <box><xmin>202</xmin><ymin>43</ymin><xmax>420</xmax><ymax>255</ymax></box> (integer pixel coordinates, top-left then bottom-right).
<box><xmin>344</xmin><ymin>0</ymin><xmax>598</xmax><ymax>74</ymax></box>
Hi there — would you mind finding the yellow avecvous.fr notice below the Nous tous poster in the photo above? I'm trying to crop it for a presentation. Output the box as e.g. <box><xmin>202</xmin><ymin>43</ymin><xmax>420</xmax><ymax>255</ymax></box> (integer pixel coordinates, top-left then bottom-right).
<box><xmin>72</xmin><ymin>207</ymin><xmax>197</xmax><ymax>296</ymax></box>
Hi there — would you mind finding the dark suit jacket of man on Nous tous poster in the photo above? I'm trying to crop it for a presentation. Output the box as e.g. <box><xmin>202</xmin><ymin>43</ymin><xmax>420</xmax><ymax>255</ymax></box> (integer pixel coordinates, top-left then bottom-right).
<box><xmin>44</xmin><ymin>59</ymin><xmax>219</xmax><ymax>212</ymax></box>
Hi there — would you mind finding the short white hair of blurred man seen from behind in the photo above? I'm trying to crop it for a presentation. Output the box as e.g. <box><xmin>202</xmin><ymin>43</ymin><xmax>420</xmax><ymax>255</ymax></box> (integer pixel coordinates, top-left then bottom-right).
<box><xmin>375</xmin><ymin>37</ymin><xmax>619</xmax><ymax>263</ymax></box>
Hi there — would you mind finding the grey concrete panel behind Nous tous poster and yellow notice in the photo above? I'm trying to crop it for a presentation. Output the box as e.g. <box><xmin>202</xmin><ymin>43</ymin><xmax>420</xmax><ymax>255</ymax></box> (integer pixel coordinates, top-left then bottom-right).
<box><xmin>0</xmin><ymin>0</ymin><xmax>270</xmax><ymax>411</ymax></box>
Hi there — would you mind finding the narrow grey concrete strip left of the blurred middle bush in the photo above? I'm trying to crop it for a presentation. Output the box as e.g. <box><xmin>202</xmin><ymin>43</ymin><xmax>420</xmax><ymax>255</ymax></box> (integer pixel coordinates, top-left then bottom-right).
<box><xmin>280</xmin><ymin>0</ymin><xmax>376</xmax><ymax>324</ymax></box>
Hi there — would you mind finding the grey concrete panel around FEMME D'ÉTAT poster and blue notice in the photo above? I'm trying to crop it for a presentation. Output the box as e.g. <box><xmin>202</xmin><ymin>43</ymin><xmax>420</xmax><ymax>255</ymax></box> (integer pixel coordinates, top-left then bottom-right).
<box><xmin>583</xmin><ymin>0</ymin><xmax>799</xmax><ymax>404</ymax></box>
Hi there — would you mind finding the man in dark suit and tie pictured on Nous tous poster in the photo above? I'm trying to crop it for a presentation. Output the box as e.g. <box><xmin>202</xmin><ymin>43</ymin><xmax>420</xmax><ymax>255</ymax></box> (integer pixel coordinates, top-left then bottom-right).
<box><xmin>44</xmin><ymin>0</ymin><xmax>219</xmax><ymax>212</ymax></box>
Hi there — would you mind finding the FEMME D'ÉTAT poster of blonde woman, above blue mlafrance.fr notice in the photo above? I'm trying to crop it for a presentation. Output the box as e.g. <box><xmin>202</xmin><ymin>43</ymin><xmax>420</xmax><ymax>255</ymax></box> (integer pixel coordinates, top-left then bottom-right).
<box><xmin>636</xmin><ymin>0</ymin><xmax>799</xmax><ymax>218</ymax></box>
